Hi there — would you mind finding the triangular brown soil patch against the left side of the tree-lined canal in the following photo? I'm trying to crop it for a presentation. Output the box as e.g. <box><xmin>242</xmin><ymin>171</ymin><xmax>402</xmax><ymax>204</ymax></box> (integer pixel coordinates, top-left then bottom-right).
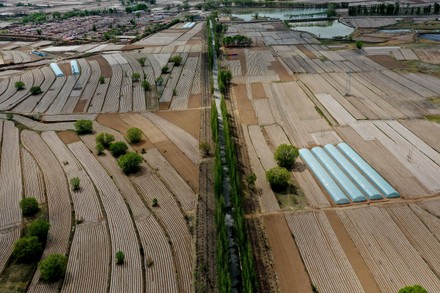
<box><xmin>155</xmin><ymin>109</ymin><xmax>200</xmax><ymax>139</ymax></box>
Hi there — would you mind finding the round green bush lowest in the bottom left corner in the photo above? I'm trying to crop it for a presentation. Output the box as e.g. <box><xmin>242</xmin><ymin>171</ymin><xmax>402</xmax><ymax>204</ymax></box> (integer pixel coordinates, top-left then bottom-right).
<box><xmin>38</xmin><ymin>254</ymin><xmax>67</xmax><ymax>282</ymax></box>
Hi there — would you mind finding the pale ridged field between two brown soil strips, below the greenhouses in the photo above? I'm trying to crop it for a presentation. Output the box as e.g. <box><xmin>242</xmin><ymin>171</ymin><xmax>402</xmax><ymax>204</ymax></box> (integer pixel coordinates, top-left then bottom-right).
<box><xmin>286</xmin><ymin>212</ymin><xmax>365</xmax><ymax>292</ymax></box>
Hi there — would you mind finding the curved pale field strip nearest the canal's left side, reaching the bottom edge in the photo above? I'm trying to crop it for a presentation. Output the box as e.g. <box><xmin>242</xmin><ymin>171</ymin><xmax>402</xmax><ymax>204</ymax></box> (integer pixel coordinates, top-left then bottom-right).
<box><xmin>133</xmin><ymin>173</ymin><xmax>193</xmax><ymax>293</ymax></box>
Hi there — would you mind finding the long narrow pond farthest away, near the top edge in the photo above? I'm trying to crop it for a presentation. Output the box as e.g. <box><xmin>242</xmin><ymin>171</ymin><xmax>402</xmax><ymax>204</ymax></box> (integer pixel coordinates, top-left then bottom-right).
<box><xmin>232</xmin><ymin>8</ymin><xmax>327</xmax><ymax>21</ymax></box>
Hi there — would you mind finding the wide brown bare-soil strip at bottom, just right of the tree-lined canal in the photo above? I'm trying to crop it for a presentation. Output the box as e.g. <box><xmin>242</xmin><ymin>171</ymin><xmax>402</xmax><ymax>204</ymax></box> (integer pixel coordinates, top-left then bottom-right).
<box><xmin>263</xmin><ymin>214</ymin><xmax>312</xmax><ymax>293</ymax></box>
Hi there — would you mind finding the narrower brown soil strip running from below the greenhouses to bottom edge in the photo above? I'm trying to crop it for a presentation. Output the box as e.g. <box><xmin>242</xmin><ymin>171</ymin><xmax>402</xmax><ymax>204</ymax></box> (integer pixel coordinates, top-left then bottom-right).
<box><xmin>324</xmin><ymin>210</ymin><xmax>380</xmax><ymax>293</ymax></box>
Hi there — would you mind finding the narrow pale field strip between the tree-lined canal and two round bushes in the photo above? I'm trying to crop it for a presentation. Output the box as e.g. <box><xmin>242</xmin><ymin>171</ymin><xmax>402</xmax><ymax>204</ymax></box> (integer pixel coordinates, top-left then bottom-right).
<box><xmin>242</xmin><ymin>124</ymin><xmax>280</xmax><ymax>212</ymax></box>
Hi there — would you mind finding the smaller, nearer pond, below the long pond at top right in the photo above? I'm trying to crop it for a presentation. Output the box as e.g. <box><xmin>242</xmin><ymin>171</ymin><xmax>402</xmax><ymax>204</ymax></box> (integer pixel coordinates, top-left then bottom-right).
<box><xmin>289</xmin><ymin>20</ymin><xmax>354</xmax><ymax>39</ymax></box>
